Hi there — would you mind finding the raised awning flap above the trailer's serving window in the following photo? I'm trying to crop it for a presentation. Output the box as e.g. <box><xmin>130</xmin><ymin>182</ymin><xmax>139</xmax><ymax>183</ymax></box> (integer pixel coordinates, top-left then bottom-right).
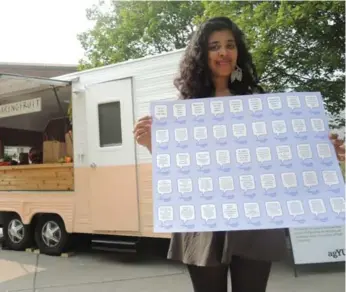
<box><xmin>0</xmin><ymin>73</ymin><xmax>71</xmax><ymax>100</ymax></box>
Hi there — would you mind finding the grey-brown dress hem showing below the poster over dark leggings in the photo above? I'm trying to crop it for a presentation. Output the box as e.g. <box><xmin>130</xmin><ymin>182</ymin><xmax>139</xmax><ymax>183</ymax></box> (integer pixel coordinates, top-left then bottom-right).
<box><xmin>167</xmin><ymin>92</ymin><xmax>287</xmax><ymax>266</ymax></box>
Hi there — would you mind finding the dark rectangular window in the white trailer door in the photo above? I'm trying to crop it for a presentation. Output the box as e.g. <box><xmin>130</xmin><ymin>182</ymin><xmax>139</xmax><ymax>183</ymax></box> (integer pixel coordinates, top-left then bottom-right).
<box><xmin>98</xmin><ymin>101</ymin><xmax>122</xmax><ymax>147</ymax></box>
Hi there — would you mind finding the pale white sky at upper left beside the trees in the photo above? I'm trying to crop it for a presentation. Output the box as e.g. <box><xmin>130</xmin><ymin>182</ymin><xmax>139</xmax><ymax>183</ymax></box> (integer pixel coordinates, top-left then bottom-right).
<box><xmin>0</xmin><ymin>0</ymin><xmax>98</xmax><ymax>64</ymax></box>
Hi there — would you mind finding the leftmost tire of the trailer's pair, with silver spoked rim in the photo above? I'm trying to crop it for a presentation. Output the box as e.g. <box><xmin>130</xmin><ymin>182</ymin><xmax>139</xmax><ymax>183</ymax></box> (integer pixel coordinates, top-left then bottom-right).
<box><xmin>3</xmin><ymin>214</ymin><xmax>33</xmax><ymax>251</ymax></box>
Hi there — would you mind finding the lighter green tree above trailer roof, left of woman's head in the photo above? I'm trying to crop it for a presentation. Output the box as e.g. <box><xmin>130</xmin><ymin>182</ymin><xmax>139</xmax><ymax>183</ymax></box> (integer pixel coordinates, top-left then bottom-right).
<box><xmin>78</xmin><ymin>0</ymin><xmax>203</xmax><ymax>69</ymax></box>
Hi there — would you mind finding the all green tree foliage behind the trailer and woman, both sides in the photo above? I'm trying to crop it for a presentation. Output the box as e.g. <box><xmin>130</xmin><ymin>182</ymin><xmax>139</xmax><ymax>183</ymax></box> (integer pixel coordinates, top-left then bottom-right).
<box><xmin>79</xmin><ymin>1</ymin><xmax>345</xmax><ymax>126</ymax></box>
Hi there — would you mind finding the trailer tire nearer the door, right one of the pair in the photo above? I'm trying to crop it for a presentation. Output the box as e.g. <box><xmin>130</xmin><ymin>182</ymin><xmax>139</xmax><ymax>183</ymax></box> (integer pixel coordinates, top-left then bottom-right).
<box><xmin>35</xmin><ymin>215</ymin><xmax>69</xmax><ymax>256</ymax></box>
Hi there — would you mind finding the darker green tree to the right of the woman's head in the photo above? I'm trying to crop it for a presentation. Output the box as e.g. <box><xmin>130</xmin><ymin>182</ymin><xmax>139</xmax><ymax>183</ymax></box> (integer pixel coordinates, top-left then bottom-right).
<box><xmin>196</xmin><ymin>1</ymin><xmax>345</xmax><ymax>127</ymax></box>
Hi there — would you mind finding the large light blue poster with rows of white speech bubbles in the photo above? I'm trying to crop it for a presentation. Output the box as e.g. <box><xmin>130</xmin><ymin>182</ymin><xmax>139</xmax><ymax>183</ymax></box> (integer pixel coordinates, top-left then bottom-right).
<box><xmin>151</xmin><ymin>92</ymin><xmax>345</xmax><ymax>233</ymax></box>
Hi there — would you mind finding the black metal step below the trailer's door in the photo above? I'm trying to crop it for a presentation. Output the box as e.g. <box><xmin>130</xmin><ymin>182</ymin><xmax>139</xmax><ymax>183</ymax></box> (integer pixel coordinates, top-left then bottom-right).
<box><xmin>91</xmin><ymin>237</ymin><xmax>139</xmax><ymax>254</ymax></box>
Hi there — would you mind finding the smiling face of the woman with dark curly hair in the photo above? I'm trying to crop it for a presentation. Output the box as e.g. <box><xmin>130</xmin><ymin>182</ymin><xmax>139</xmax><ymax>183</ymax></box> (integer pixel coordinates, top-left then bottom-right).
<box><xmin>208</xmin><ymin>30</ymin><xmax>238</xmax><ymax>77</ymax></box>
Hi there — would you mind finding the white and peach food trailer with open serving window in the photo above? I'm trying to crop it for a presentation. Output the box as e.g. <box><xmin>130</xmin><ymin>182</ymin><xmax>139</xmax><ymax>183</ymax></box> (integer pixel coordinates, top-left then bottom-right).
<box><xmin>0</xmin><ymin>50</ymin><xmax>183</xmax><ymax>255</ymax></box>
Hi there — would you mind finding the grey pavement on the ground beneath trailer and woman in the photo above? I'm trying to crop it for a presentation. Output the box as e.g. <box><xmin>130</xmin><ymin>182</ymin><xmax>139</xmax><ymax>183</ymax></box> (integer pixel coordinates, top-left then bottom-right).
<box><xmin>0</xmin><ymin>246</ymin><xmax>345</xmax><ymax>292</ymax></box>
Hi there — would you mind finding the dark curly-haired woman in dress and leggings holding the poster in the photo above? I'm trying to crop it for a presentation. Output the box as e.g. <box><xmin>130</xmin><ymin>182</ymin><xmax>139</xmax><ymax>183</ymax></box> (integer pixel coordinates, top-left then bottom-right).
<box><xmin>134</xmin><ymin>17</ymin><xmax>345</xmax><ymax>292</ymax></box>
